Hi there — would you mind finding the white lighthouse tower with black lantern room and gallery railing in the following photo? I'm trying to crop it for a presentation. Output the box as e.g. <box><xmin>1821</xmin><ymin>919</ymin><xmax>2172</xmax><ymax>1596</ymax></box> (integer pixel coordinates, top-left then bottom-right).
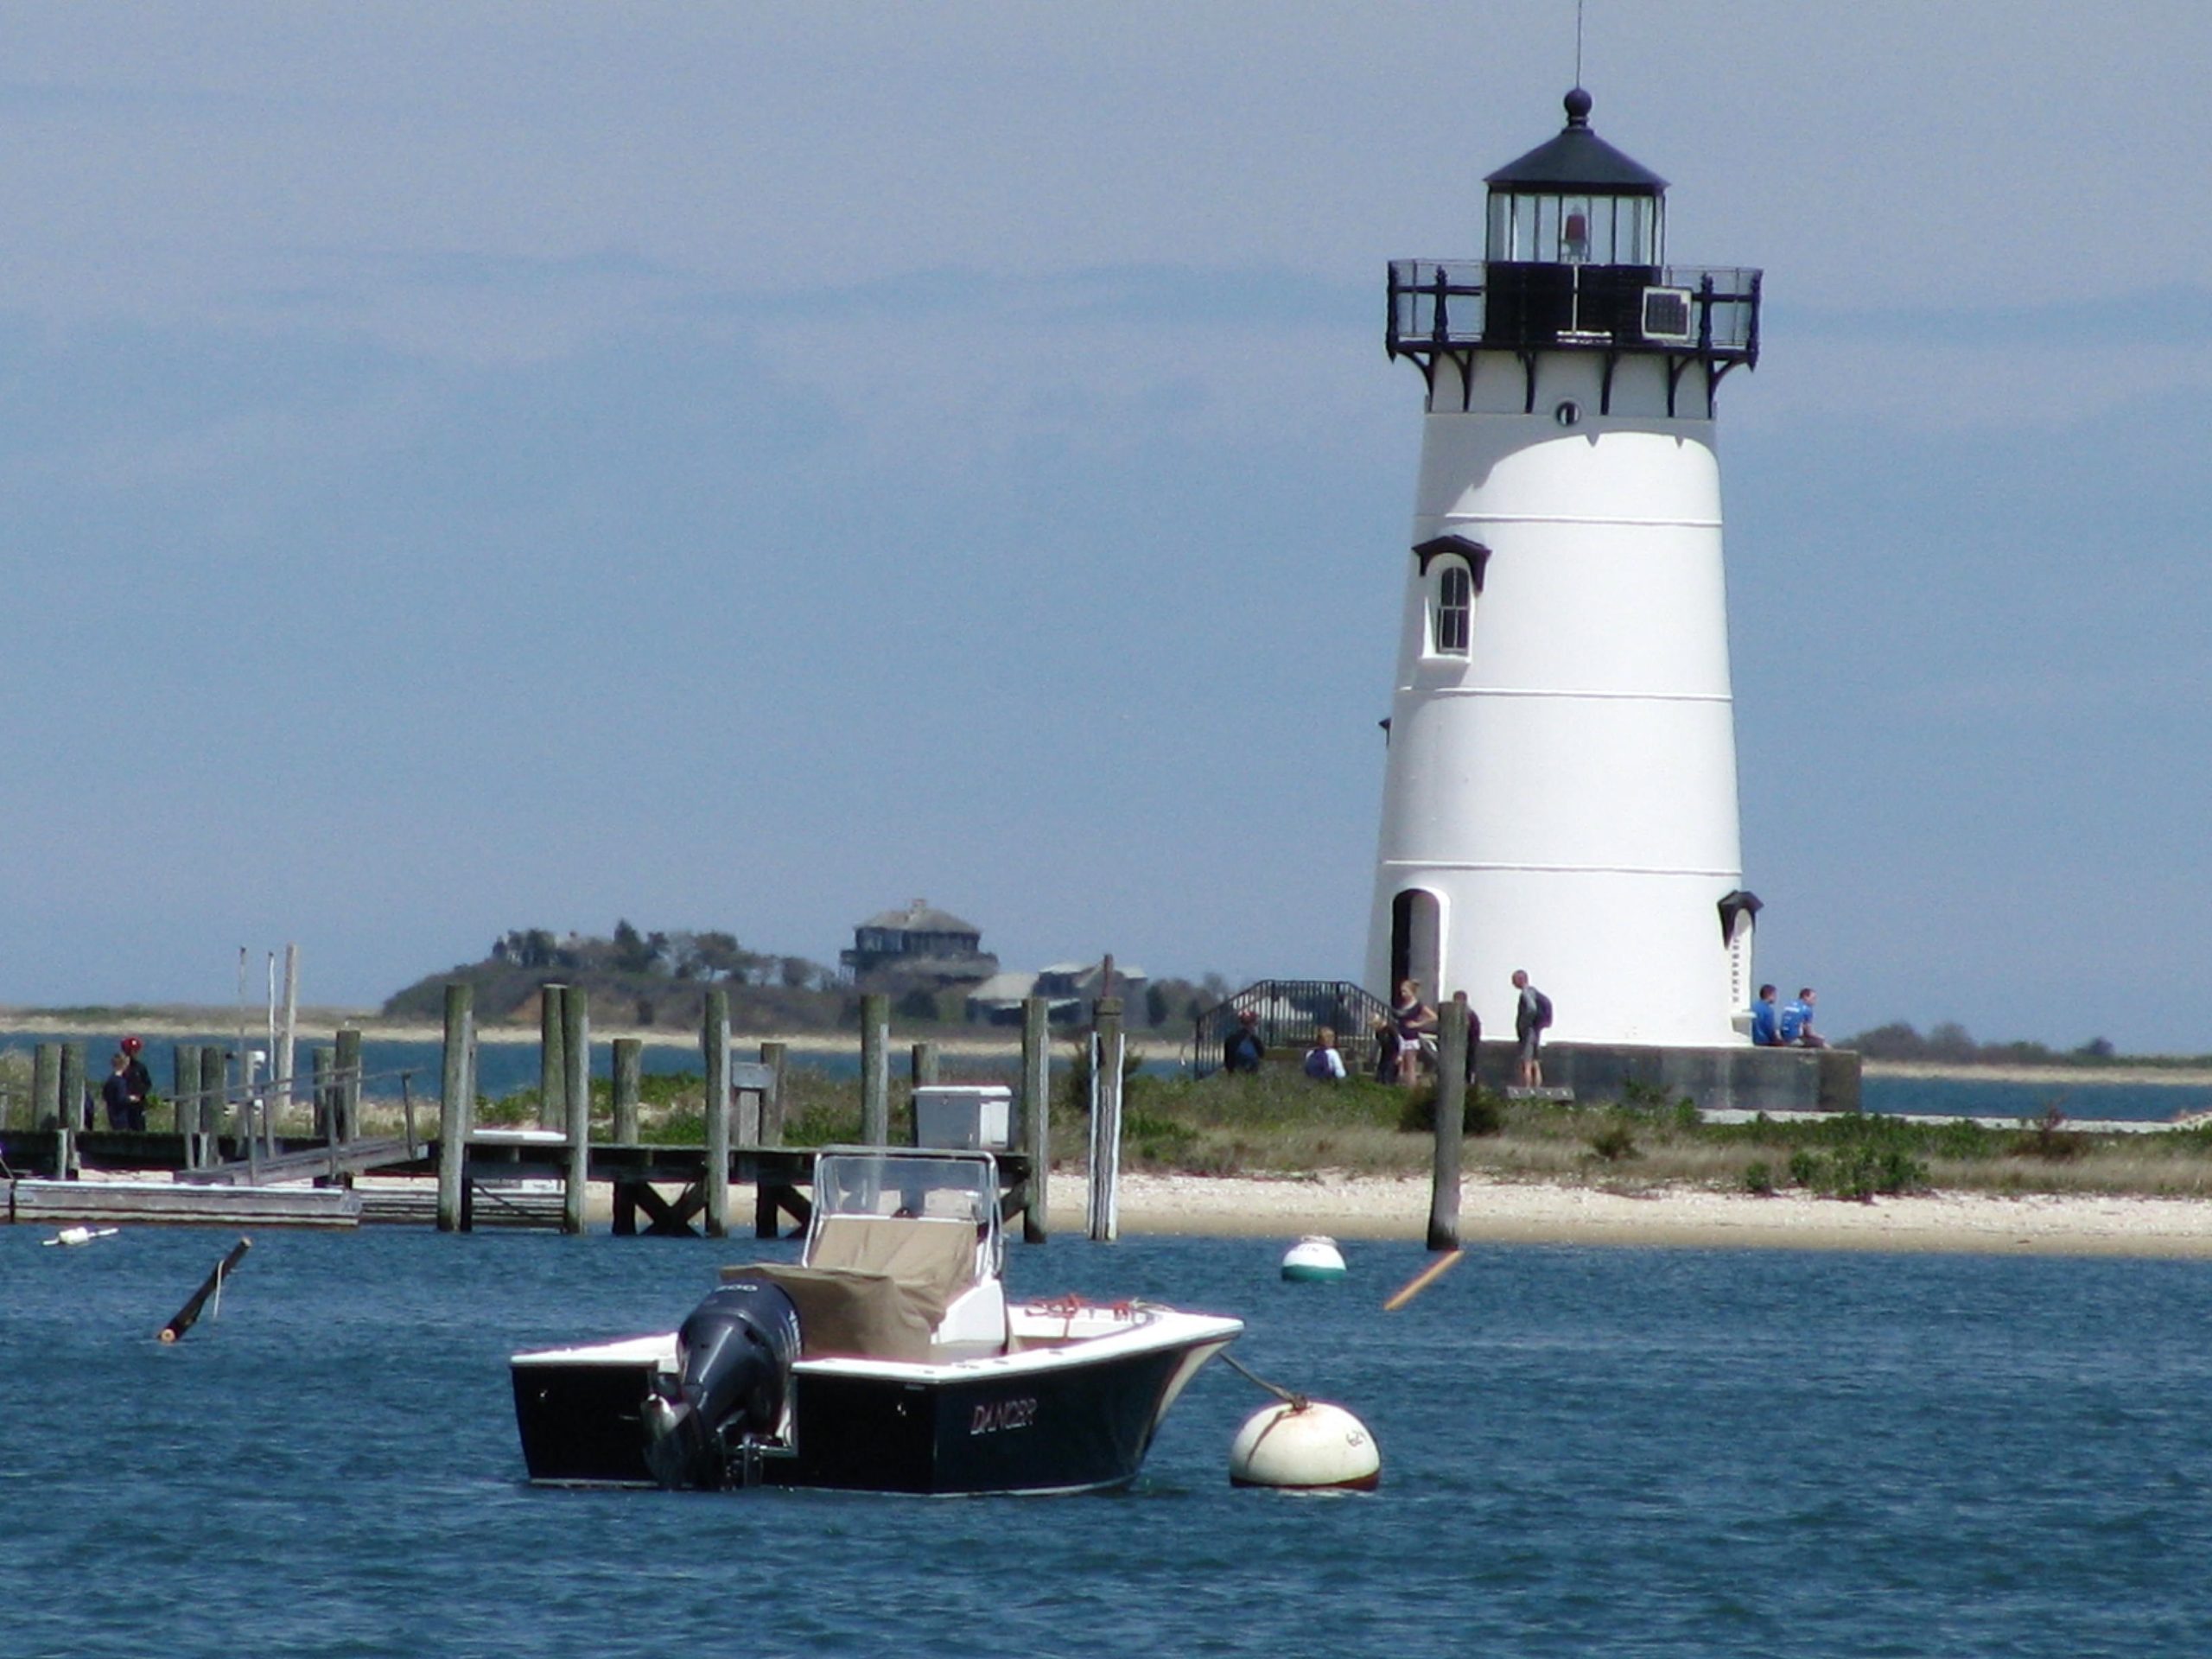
<box><xmin>1367</xmin><ymin>88</ymin><xmax>1758</xmax><ymax>1048</ymax></box>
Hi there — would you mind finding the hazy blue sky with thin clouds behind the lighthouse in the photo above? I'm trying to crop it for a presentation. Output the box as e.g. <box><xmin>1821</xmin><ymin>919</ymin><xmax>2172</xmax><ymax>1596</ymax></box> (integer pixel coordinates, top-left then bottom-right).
<box><xmin>0</xmin><ymin>0</ymin><xmax>2212</xmax><ymax>1051</ymax></box>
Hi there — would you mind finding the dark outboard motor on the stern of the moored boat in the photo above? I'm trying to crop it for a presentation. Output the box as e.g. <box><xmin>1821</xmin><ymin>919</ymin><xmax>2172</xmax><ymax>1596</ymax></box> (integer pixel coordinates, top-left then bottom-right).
<box><xmin>644</xmin><ymin>1279</ymin><xmax>798</xmax><ymax>1491</ymax></box>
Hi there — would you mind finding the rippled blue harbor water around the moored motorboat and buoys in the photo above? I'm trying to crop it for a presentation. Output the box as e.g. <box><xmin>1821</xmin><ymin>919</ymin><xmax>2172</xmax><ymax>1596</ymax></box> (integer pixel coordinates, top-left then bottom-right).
<box><xmin>0</xmin><ymin>1228</ymin><xmax>2212</xmax><ymax>1659</ymax></box>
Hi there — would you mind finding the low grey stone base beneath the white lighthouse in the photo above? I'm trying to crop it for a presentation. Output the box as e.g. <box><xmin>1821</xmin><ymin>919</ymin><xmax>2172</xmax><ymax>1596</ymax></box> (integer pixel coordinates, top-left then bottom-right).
<box><xmin>1476</xmin><ymin>1039</ymin><xmax>1858</xmax><ymax>1113</ymax></box>
